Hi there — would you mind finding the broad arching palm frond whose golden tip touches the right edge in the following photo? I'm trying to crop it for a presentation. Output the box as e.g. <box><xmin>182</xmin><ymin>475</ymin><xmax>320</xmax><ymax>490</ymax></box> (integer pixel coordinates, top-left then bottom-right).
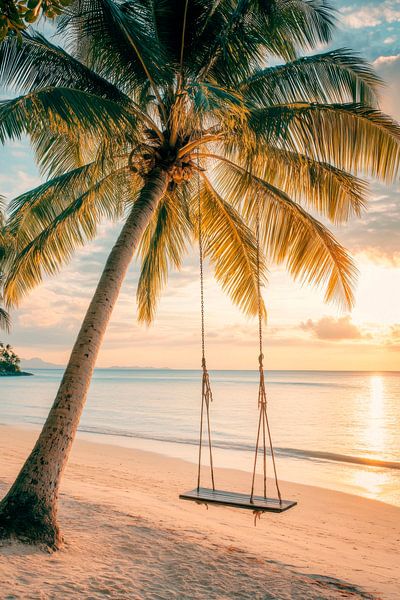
<box><xmin>248</xmin><ymin>103</ymin><xmax>400</xmax><ymax>181</ymax></box>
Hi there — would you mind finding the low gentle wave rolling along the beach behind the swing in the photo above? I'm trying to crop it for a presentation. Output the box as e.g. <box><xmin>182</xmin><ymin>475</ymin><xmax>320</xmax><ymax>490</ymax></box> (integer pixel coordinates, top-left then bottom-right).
<box><xmin>79</xmin><ymin>427</ymin><xmax>400</xmax><ymax>470</ymax></box>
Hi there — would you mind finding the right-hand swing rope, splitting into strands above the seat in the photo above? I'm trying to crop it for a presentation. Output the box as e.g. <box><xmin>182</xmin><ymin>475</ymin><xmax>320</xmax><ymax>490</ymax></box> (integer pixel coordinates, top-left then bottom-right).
<box><xmin>250</xmin><ymin>194</ymin><xmax>282</xmax><ymax>504</ymax></box>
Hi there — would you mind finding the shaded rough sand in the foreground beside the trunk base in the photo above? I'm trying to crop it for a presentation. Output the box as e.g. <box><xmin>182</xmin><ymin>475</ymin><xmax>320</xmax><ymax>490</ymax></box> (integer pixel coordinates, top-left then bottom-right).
<box><xmin>0</xmin><ymin>498</ymin><xmax>373</xmax><ymax>600</ymax></box>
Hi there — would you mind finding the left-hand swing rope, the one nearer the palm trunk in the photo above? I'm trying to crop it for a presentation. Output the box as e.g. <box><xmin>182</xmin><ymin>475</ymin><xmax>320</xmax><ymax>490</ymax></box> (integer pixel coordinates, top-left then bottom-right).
<box><xmin>197</xmin><ymin>149</ymin><xmax>215</xmax><ymax>491</ymax></box>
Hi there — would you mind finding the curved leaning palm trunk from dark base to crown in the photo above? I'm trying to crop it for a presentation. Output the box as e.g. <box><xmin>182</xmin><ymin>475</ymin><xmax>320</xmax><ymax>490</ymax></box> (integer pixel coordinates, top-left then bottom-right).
<box><xmin>0</xmin><ymin>169</ymin><xmax>168</xmax><ymax>549</ymax></box>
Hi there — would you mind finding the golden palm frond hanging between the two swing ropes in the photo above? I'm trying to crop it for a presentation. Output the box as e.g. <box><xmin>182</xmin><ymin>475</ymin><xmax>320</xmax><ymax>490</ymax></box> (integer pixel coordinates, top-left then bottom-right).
<box><xmin>193</xmin><ymin>173</ymin><xmax>266</xmax><ymax>316</ymax></box>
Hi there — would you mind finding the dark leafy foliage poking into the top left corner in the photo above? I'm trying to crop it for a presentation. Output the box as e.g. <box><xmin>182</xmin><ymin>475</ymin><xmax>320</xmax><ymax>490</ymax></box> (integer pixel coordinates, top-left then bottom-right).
<box><xmin>0</xmin><ymin>0</ymin><xmax>73</xmax><ymax>42</ymax></box>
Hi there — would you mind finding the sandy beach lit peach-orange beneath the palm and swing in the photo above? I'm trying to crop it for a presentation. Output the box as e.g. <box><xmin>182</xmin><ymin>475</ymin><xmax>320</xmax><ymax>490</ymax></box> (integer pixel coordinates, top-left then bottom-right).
<box><xmin>0</xmin><ymin>426</ymin><xmax>400</xmax><ymax>600</ymax></box>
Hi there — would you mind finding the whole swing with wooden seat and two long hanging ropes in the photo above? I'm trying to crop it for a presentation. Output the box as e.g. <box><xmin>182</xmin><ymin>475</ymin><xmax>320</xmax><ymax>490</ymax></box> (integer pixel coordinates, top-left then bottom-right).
<box><xmin>179</xmin><ymin>161</ymin><xmax>297</xmax><ymax>518</ymax></box>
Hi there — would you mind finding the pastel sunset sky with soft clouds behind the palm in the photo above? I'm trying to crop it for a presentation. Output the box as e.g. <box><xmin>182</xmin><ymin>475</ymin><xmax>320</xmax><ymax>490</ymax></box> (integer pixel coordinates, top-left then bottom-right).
<box><xmin>0</xmin><ymin>0</ymin><xmax>400</xmax><ymax>371</ymax></box>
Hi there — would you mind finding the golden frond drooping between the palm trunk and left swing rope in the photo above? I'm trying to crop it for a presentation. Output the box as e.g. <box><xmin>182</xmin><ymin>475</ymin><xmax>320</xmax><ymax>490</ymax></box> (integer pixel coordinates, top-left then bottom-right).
<box><xmin>137</xmin><ymin>190</ymin><xmax>191</xmax><ymax>325</ymax></box>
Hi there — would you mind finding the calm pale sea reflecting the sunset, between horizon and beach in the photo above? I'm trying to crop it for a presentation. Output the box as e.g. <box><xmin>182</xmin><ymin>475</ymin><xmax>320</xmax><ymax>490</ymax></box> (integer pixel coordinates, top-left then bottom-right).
<box><xmin>0</xmin><ymin>369</ymin><xmax>400</xmax><ymax>506</ymax></box>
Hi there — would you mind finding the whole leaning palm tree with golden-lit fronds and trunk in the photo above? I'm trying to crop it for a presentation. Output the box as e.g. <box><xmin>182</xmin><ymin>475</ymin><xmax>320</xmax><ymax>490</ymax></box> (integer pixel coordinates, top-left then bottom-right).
<box><xmin>0</xmin><ymin>0</ymin><xmax>400</xmax><ymax>548</ymax></box>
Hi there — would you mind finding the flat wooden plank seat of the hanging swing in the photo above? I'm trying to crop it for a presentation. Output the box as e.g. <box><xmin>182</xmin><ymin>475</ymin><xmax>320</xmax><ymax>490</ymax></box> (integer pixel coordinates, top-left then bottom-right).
<box><xmin>179</xmin><ymin>487</ymin><xmax>297</xmax><ymax>513</ymax></box>
